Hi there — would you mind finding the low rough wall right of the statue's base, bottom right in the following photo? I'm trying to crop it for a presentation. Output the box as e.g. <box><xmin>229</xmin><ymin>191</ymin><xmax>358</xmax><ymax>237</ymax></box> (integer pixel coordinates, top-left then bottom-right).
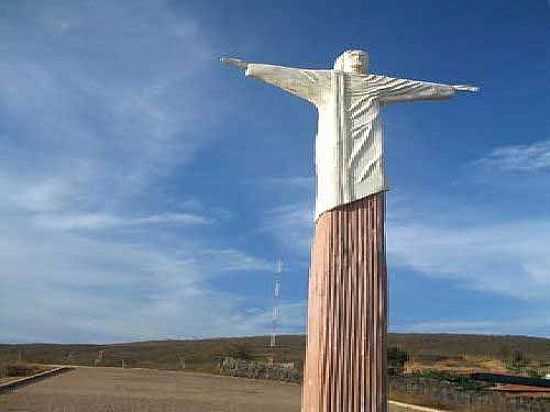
<box><xmin>390</xmin><ymin>376</ymin><xmax>550</xmax><ymax>412</ymax></box>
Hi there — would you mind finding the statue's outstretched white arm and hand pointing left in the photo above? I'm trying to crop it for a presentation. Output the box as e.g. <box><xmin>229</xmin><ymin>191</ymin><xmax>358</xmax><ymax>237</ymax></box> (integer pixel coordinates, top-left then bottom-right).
<box><xmin>221</xmin><ymin>58</ymin><xmax>330</xmax><ymax>105</ymax></box>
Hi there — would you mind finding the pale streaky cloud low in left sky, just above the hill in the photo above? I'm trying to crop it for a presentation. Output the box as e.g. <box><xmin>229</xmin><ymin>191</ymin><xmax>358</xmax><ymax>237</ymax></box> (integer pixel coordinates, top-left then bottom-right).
<box><xmin>0</xmin><ymin>217</ymin><xmax>273</xmax><ymax>342</ymax></box>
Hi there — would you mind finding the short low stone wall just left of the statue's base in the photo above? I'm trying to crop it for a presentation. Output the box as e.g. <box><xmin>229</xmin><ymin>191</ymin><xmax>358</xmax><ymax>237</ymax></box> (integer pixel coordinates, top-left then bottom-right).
<box><xmin>218</xmin><ymin>357</ymin><xmax>302</xmax><ymax>383</ymax></box>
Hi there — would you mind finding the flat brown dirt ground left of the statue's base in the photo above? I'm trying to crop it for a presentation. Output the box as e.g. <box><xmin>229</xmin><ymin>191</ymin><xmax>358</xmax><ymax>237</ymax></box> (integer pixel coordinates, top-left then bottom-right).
<box><xmin>0</xmin><ymin>368</ymin><xmax>422</xmax><ymax>412</ymax></box>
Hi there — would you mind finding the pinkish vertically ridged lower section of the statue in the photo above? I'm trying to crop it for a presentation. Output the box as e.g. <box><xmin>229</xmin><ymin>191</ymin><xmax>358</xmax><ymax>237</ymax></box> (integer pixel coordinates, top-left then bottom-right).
<box><xmin>302</xmin><ymin>193</ymin><xmax>387</xmax><ymax>412</ymax></box>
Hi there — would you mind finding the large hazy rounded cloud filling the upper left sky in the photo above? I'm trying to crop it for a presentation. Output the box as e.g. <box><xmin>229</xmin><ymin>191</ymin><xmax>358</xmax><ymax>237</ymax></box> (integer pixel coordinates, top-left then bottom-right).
<box><xmin>0</xmin><ymin>1</ymin><xmax>222</xmax><ymax>205</ymax></box>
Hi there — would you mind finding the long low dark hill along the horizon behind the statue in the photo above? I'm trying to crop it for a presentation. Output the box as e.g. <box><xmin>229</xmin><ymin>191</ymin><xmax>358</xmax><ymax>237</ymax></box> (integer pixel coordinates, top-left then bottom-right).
<box><xmin>0</xmin><ymin>333</ymin><xmax>550</xmax><ymax>372</ymax></box>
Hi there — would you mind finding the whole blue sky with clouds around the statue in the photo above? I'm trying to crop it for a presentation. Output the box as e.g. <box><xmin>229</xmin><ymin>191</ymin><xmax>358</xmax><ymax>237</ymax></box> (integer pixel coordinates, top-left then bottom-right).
<box><xmin>0</xmin><ymin>0</ymin><xmax>550</xmax><ymax>342</ymax></box>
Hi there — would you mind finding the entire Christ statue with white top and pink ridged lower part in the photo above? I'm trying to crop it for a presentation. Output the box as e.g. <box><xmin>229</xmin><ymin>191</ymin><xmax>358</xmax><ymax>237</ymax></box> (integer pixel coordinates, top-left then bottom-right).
<box><xmin>222</xmin><ymin>50</ymin><xmax>478</xmax><ymax>412</ymax></box>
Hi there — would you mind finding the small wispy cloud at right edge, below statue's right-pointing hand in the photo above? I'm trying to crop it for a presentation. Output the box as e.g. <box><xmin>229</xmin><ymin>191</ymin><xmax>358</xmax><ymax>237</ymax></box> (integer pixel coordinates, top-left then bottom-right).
<box><xmin>476</xmin><ymin>140</ymin><xmax>550</xmax><ymax>173</ymax></box>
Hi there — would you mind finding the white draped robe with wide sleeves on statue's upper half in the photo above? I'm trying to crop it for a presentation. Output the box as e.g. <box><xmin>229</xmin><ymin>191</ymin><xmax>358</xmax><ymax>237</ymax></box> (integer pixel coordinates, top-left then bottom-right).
<box><xmin>246</xmin><ymin>64</ymin><xmax>454</xmax><ymax>220</ymax></box>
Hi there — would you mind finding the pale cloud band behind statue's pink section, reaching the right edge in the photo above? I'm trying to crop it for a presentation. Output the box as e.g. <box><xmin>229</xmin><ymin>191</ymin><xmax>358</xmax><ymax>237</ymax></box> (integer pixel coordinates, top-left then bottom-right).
<box><xmin>264</xmin><ymin>194</ymin><xmax>550</xmax><ymax>300</ymax></box>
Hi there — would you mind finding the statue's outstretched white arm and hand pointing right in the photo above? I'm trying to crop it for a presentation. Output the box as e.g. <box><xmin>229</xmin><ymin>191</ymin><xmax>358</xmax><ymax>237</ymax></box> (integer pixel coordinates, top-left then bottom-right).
<box><xmin>369</xmin><ymin>76</ymin><xmax>479</xmax><ymax>103</ymax></box>
